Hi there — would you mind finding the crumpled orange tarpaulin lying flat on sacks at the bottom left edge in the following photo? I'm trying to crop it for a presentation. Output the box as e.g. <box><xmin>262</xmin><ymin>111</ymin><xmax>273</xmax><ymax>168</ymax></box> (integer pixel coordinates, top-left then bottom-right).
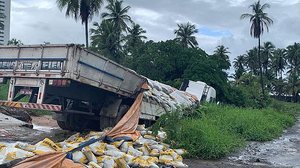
<box><xmin>14</xmin><ymin>152</ymin><xmax>84</xmax><ymax>168</ymax></box>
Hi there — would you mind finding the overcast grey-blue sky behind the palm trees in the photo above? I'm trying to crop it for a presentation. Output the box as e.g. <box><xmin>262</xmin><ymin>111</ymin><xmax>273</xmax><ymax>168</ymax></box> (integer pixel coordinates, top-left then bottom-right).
<box><xmin>11</xmin><ymin>0</ymin><xmax>300</xmax><ymax>67</ymax></box>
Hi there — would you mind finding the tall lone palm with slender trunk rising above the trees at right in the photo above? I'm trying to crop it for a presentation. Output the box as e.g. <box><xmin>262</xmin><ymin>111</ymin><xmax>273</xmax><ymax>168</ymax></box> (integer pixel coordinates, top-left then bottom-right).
<box><xmin>241</xmin><ymin>0</ymin><xmax>273</xmax><ymax>96</ymax></box>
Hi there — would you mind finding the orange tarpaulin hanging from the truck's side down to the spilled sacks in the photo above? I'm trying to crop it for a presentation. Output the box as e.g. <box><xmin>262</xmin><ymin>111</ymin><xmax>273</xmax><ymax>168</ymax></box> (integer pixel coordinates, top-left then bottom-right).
<box><xmin>106</xmin><ymin>83</ymin><xmax>148</xmax><ymax>141</ymax></box>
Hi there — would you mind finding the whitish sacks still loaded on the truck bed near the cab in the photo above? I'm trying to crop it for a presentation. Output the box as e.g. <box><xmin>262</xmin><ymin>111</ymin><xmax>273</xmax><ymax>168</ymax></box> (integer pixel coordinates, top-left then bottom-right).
<box><xmin>144</xmin><ymin>79</ymin><xmax>199</xmax><ymax>111</ymax></box>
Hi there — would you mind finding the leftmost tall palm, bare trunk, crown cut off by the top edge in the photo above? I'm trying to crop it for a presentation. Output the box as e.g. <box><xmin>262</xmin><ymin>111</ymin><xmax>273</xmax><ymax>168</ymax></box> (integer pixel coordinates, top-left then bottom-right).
<box><xmin>56</xmin><ymin>0</ymin><xmax>103</xmax><ymax>48</ymax></box>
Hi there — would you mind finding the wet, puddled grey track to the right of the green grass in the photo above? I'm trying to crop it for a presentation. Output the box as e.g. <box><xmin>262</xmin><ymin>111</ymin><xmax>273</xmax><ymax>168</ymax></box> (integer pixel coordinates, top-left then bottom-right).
<box><xmin>229</xmin><ymin>118</ymin><xmax>300</xmax><ymax>168</ymax></box>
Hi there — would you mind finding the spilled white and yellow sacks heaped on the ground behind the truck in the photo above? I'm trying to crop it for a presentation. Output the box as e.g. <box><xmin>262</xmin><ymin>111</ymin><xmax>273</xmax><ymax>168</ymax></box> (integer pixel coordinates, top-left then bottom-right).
<box><xmin>0</xmin><ymin>126</ymin><xmax>188</xmax><ymax>168</ymax></box>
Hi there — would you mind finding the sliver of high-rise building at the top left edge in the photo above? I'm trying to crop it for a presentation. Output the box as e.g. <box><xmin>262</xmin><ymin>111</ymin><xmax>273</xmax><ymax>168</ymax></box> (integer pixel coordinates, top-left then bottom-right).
<box><xmin>0</xmin><ymin>0</ymin><xmax>11</xmax><ymax>45</ymax></box>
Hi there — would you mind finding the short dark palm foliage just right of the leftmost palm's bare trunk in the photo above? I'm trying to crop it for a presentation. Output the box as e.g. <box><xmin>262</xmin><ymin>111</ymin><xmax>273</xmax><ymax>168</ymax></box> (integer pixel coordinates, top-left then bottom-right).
<box><xmin>90</xmin><ymin>21</ymin><xmax>124</xmax><ymax>62</ymax></box>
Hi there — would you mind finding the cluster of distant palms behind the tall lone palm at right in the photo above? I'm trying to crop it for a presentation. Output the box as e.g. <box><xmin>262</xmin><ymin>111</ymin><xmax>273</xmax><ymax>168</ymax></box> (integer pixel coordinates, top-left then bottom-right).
<box><xmin>234</xmin><ymin>42</ymin><xmax>300</xmax><ymax>102</ymax></box>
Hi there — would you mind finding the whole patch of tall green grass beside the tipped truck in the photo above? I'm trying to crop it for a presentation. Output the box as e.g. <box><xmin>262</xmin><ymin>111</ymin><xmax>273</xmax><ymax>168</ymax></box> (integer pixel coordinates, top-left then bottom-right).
<box><xmin>152</xmin><ymin>104</ymin><xmax>296</xmax><ymax>159</ymax></box>
